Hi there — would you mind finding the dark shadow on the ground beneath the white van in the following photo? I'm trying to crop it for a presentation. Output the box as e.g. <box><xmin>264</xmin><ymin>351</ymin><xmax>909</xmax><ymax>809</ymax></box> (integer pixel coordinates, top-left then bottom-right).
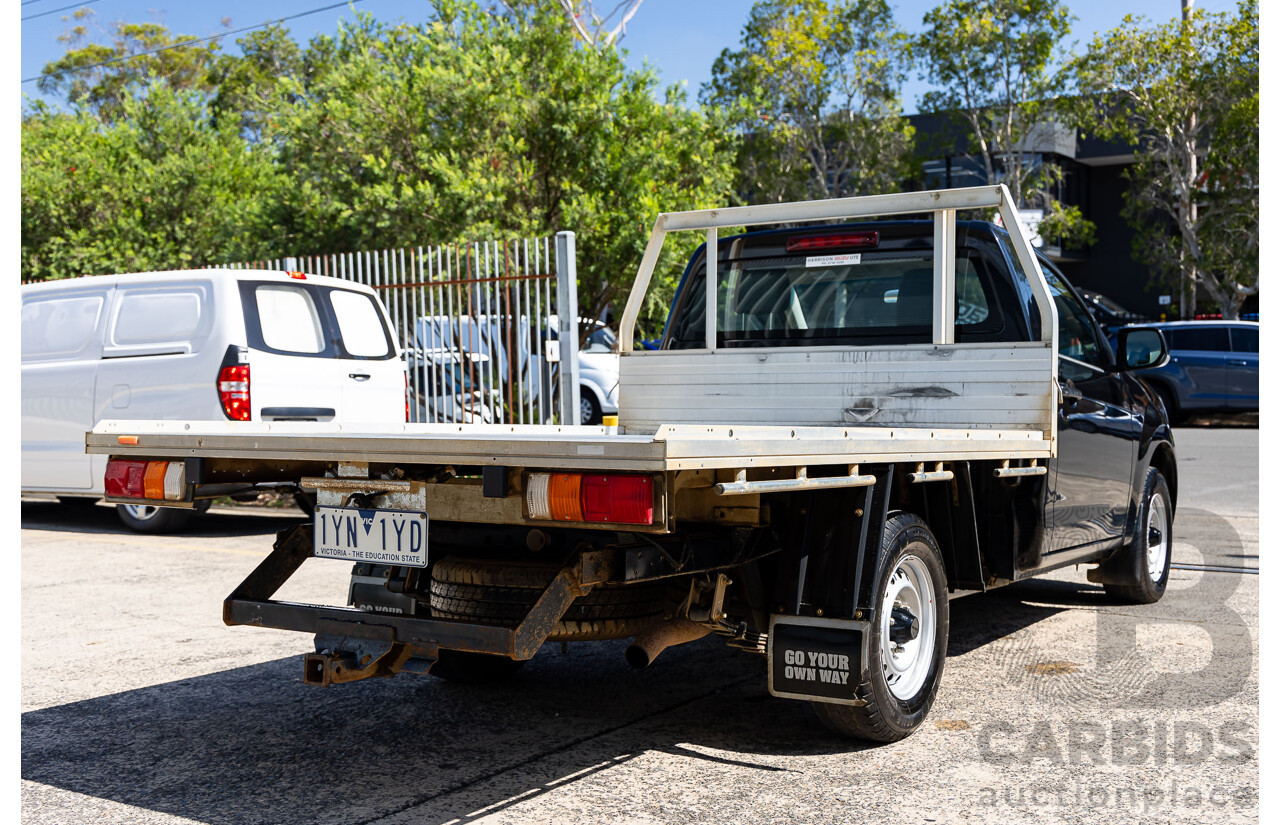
<box><xmin>22</xmin><ymin>499</ymin><xmax>305</xmax><ymax>538</ymax></box>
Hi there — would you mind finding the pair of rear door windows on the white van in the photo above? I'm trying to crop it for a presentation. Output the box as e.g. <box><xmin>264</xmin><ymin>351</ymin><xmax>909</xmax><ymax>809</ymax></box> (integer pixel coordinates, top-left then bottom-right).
<box><xmin>241</xmin><ymin>281</ymin><xmax>396</xmax><ymax>361</ymax></box>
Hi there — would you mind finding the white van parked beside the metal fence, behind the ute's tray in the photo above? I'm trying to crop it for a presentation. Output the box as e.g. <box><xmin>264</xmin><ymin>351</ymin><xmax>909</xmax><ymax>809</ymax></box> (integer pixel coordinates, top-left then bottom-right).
<box><xmin>22</xmin><ymin>270</ymin><xmax>407</xmax><ymax>532</ymax></box>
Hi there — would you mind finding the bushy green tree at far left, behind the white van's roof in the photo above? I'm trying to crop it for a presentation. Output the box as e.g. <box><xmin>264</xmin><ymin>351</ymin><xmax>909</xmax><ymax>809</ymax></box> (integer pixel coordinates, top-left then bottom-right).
<box><xmin>22</xmin><ymin>82</ymin><xmax>280</xmax><ymax>280</ymax></box>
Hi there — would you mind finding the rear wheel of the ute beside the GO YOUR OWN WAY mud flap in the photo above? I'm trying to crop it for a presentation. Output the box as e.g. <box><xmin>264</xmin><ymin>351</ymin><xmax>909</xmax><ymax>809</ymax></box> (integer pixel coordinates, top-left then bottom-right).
<box><xmin>813</xmin><ymin>513</ymin><xmax>951</xmax><ymax>742</ymax></box>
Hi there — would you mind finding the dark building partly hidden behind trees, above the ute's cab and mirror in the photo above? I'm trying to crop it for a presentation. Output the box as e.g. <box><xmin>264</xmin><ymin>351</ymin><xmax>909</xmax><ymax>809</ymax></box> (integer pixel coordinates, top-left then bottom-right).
<box><xmin>909</xmin><ymin>115</ymin><xmax>1257</xmax><ymax>320</ymax></box>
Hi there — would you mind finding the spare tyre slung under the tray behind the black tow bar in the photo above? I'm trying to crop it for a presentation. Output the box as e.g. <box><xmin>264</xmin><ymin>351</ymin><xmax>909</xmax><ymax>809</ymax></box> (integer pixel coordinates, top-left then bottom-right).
<box><xmin>431</xmin><ymin>556</ymin><xmax>662</xmax><ymax>641</ymax></box>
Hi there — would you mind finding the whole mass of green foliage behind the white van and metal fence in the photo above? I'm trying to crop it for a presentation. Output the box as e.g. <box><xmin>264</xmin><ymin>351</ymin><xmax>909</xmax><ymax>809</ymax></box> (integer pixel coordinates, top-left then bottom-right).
<box><xmin>23</xmin><ymin>0</ymin><xmax>732</xmax><ymax>334</ymax></box>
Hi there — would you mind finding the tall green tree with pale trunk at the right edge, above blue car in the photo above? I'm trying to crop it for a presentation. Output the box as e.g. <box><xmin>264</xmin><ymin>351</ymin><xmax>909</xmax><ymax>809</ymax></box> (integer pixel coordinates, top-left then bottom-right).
<box><xmin>1075</xmin><ymin>0</ymin><xmax>1258</xmax><ymax>318</ymax></box>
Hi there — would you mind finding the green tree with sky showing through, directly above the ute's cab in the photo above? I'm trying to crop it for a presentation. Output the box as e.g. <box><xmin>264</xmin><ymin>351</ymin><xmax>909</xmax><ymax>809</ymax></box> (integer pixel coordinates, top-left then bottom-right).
<box><xmin>701</xmin><ymin>0</ymin><xmax>914</xmax><ymax>201</ymax></box>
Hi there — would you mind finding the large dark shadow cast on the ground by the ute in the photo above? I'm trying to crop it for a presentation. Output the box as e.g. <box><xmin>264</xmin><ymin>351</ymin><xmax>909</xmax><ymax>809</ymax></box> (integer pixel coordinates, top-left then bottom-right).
<box><xmin>22</xmin><ymin>585</ymin><xmax>1066</xmax><ymax>825</ymax></box>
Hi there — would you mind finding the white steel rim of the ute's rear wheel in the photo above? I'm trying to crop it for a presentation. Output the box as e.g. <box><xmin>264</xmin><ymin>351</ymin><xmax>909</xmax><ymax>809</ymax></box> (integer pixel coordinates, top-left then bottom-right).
<box><xmin>879</xmin><ymin>555</ymin><xmax>938</xmax><ymax>701</ymax></box>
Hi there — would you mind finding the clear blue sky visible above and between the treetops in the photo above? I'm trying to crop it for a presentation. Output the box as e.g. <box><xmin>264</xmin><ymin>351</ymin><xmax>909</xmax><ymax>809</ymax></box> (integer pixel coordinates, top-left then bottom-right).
<box><xmin>20</xmin><ymin>0</ymin><xmax>1235</xmax><ymax>111</ymax></box>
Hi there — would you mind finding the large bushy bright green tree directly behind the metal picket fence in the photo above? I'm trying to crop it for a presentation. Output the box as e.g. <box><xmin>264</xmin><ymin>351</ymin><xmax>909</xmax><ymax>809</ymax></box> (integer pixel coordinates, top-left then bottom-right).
<box><xmin>265</xmin><ymin>1</ymin><xmax>732</xmax><ymax>334</ymax></box>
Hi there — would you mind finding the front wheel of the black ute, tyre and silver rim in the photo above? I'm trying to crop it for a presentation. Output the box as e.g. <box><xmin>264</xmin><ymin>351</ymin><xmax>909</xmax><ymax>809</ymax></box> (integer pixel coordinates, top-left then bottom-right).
<box><xmin>1103</xmin><ymin>468</ymin><xmax>1174</xmax><ymax>605</ymax></box>
